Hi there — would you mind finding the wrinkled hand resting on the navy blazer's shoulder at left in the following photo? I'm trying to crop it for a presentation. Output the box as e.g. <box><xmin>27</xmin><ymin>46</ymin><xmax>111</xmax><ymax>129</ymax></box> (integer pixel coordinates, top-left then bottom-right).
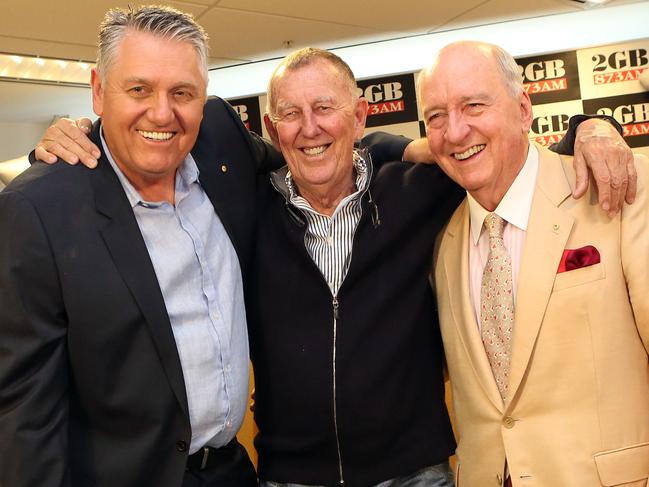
<box><xmin>35</xmin><ymin>118</ymin><xmax>100</xmax><ymax>168</ymax></box>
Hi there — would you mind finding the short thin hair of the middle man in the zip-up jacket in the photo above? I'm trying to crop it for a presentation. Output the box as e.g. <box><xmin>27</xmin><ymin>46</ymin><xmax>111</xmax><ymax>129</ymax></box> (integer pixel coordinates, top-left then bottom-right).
<box><xmin>266</xmin><ymin>47</ymin><xmax>357</xmax><ymax>121</ymax></box>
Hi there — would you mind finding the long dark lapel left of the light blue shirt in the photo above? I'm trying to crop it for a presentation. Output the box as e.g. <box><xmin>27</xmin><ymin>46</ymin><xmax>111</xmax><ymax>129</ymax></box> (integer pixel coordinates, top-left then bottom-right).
<box><xmin>90</xmin><ymin>129</ymin><xmax>189</xmax><ymax>418</ymax></box>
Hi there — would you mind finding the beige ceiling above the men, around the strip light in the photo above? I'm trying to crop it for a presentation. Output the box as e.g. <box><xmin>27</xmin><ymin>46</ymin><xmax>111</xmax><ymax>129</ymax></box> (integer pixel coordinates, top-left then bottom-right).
<box><xmin>0</xmin><ymin>0</ymin><xmax>640</xmax><ymax>122</ymax></box>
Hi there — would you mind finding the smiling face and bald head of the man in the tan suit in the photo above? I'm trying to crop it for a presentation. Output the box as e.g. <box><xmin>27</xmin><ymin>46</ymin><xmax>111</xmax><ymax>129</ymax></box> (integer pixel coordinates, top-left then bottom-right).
<box><xmin>420</xmin><ymin>43</ymin><xmax>532</xmax><ymax>211</ymax></box>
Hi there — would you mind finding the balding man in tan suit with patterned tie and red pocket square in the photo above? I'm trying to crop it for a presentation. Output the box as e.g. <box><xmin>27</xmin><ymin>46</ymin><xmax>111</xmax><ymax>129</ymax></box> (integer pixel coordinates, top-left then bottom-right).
<box><xmin>419</xmin><ymin>42</ymin><xmax>649</xmax><ymax>487</ymax></box>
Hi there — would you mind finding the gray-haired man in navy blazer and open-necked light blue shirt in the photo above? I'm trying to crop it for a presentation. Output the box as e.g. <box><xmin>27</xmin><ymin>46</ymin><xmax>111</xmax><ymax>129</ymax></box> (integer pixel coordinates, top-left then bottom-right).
<box><xmin>0</xmin><ymin>8</ymin><xmax>272</xmax><ymax>487</ymax></box>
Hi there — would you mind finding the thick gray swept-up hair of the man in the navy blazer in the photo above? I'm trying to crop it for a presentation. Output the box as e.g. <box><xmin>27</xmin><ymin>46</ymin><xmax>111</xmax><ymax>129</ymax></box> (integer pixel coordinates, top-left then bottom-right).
<box><xmin>97</xmin><ymin>5</ymin><xmax>208</xmax><ymax>82</ymax></box>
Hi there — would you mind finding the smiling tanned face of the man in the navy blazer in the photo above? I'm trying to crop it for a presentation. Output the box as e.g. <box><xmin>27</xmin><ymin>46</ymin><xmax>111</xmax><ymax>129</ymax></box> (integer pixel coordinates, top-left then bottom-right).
<box><xmin>92</xmin><ymin>30</ymin><xmax>206</xmax><ymax>196</ymax></box>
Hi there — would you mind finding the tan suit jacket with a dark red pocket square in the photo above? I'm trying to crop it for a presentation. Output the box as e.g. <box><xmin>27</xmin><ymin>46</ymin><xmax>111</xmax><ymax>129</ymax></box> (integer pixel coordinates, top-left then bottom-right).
<box><xmin>435</xmin><ymin>148</ymin><xmax>649</xmax><ymax>487</ymax></box>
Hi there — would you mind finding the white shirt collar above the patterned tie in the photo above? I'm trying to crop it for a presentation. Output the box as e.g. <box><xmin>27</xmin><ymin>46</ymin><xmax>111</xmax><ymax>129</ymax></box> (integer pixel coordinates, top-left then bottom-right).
<box><xmin>467</xmin><ymin>144</ymin><xmax>539</xmax><ymax>245</ymax></box>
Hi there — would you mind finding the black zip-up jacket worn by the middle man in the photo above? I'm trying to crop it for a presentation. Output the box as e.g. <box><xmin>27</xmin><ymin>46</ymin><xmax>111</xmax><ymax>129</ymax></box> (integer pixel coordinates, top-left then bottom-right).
<box><xmin>247</xmin><ymin>157</ymin><xmax>464</xmax><ymax>486</ymax></box>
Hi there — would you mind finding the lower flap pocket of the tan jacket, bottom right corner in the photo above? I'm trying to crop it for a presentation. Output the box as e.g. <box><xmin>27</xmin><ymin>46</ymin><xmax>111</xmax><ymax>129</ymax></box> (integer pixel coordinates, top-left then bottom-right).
<box><xmin>593</xmin><ymin>443</ymin><xmax>649</xmax><ymax>487</ymax></box>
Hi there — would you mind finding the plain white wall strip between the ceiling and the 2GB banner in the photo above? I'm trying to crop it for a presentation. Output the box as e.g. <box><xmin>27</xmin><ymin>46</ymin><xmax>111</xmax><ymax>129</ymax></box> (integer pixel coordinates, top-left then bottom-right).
<box><xmin>208</xmin><ymin>2</ymin><xmax>649</xmax><ymax>98</ymax></box>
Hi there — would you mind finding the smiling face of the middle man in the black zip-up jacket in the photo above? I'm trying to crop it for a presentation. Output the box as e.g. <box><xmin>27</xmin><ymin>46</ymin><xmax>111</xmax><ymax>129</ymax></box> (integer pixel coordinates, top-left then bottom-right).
<box><xmin>266</xmin><ymin>59</ymin><xmax>367</xmax><ymax>208</ymax></box>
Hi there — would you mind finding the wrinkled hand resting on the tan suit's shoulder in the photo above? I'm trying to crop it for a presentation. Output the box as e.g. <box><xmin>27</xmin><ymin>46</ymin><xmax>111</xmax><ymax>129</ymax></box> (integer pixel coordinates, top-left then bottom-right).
<box><xmin>572</xmin><ymin>118</ymin><xmax>637</xmax><ymax>216</ymax></box>
